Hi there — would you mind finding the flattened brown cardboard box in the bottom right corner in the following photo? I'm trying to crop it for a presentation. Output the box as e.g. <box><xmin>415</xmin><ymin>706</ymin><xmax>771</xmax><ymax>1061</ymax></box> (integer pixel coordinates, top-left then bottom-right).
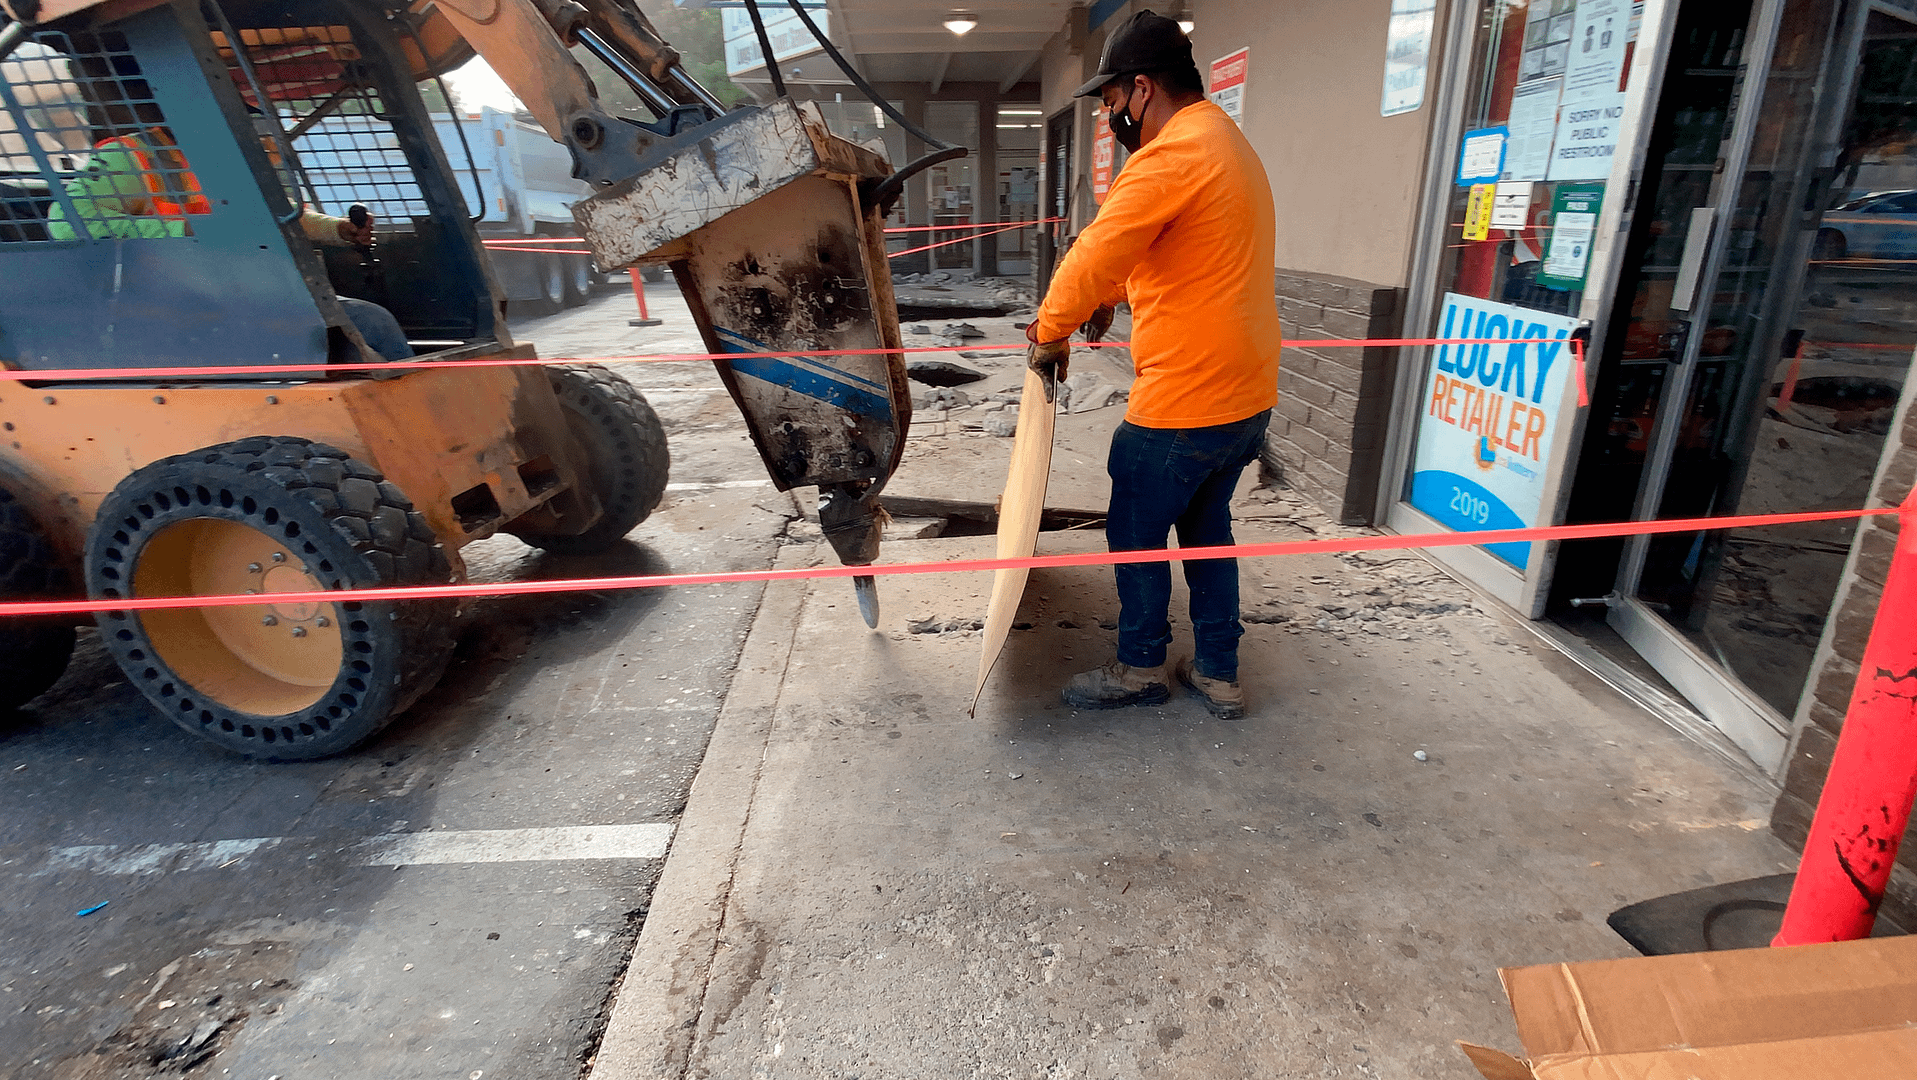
<box><xmin>1459</xmin><ymin>936</ymin><xmax>1917</xmax><ymax>1080</ymax></box>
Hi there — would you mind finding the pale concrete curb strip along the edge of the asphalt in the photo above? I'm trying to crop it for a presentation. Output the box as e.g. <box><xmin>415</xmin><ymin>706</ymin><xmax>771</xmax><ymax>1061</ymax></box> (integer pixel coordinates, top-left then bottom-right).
<box><xmin>587</xmin><ymin>547</ymin><xmax>819</xmax><ymax>1080</ymax></box>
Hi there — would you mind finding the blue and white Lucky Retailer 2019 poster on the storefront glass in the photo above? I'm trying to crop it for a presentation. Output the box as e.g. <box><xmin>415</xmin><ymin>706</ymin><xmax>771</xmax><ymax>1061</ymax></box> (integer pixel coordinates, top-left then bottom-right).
<box><xmin>1411</xmin><ymin>293</ymin><xmax>1578</xmax><ymax>570</ymax></box>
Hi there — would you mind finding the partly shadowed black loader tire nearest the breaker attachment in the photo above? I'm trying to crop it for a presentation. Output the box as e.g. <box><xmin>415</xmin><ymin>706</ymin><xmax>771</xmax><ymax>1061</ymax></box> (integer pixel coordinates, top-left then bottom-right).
<box><xmin>508</xmin><ymin>364</ymin><xmax>671</xmax><ymax>554</ymax></box>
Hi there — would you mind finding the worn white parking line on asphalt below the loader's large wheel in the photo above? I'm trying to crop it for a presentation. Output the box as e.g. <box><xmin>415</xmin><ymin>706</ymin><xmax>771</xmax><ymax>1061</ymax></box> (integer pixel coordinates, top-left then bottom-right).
<box><xmin>35</xmin><ymin>823</ymin><xmax>673</xmax><ymax>877</ymax></box>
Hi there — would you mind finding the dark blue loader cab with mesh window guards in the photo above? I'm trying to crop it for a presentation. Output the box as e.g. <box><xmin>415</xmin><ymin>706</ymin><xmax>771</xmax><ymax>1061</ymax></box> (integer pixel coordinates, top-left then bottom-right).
<box><xmin>0</xmin><ymin>0</ymin><xmax>510</xmax><ymax>380</ymax></box>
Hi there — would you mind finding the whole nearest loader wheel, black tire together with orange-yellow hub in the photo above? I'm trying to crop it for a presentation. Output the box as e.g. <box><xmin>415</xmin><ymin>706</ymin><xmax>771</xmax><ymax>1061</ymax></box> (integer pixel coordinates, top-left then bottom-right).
<box><xmin>86</xmin><ymin>435</ymin><xmax>454</xmax><ymax>762</ymax></box>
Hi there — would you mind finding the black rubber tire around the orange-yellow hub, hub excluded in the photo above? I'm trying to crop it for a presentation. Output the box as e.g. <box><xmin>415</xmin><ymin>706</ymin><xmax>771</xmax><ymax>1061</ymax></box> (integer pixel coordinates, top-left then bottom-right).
<box><xmin>86</xmin><ymin>435</ymin><xmax>454</xmax><ymax>762</ymax></box>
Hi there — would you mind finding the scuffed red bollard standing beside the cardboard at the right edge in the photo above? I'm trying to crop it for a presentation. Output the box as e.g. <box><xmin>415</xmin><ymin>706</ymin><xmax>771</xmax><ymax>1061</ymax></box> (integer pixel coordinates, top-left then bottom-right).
<box><xmin>1771</xmin><ymin>491</ymin><xmax>1917</xmax><ymax>946</ymax></box>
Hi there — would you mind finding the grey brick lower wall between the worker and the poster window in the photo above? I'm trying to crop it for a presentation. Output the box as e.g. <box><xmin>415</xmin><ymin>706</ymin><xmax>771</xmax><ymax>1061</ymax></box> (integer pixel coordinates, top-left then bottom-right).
<box><xmin>1263</xmin><ymin>270</ymin><xmax>1401</xmax><ymax>526</ymax></box>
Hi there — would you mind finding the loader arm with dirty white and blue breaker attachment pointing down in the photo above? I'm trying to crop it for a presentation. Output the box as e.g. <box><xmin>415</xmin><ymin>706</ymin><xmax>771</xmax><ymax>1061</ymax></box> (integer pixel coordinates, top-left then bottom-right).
<box><xmin>414</xmin><ymin>0</ymin><xmax>939</xmax><ymax>623</ymax></box>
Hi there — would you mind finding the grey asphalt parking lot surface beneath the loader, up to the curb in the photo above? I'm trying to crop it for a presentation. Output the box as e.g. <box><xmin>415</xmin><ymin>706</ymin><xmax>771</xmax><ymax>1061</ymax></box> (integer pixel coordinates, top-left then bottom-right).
<box><xmin>0</xmin><ymin>286</ymin><xmax>792</xmax><ymax>1080</ymax></box>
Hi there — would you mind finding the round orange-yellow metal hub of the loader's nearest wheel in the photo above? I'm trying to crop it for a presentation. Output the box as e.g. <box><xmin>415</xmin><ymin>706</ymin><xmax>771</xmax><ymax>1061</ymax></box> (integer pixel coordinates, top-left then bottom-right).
<box><xmin>132</xmin><ymin>518</ymin><xmax>345</xmax><ymax>717</ymax></box>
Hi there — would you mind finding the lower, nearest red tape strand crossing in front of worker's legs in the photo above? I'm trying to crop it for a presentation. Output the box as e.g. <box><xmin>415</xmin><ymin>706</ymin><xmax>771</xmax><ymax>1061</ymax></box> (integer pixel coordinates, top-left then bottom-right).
<box><xmin>0</xmin><ymin>506</ymin><xmax>1898</xmax><ymax>618</ymax></box>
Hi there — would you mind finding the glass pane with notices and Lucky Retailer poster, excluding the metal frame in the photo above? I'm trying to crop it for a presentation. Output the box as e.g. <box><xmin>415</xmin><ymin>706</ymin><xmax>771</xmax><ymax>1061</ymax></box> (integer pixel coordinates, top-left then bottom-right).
<box><xmin>1407</xmin><ymin>0</ymin><xmax>1639</xmax><ymax>572</ymax></box>
